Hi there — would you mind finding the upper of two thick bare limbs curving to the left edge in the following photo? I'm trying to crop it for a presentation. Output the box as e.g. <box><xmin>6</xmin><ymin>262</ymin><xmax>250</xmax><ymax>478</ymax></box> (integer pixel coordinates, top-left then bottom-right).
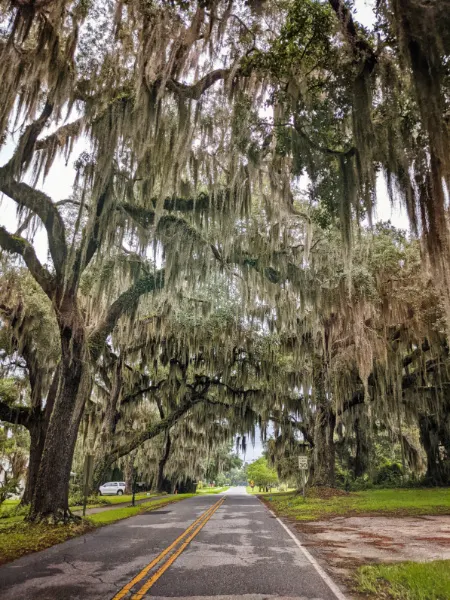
<box><xmin>0</xmin><ymin>175</ymin><xmax>67</xmax><ymax>276</ymax></box>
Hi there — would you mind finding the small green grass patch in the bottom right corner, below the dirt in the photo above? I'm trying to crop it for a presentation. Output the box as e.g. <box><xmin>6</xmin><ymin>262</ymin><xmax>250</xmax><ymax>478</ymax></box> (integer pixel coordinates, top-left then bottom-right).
<box><xmin>356</xmin><ymin>560</ymin><xmax>450</xmax><ymax>600</ymax></box>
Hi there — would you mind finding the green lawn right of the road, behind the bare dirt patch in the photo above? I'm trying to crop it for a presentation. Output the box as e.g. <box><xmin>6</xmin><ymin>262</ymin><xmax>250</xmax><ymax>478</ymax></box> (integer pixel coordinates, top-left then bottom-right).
<box><xmin>262</xmin><ymin>488</ymin><xmax>450</xmax><ymax>521</ymax></box>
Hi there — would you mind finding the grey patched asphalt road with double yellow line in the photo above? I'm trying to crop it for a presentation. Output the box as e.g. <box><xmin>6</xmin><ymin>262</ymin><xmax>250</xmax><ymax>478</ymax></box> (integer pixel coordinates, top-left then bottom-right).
<box><xmin>0</xmin><ymin>489</ymin><xmax>344</xmax><ymax>600</ymax></box>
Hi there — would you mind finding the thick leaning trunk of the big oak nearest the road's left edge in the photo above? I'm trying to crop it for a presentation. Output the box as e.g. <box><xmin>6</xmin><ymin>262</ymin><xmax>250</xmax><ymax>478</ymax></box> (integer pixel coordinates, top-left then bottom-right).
<box><xmin>29</xmin><ymin>312</ymin><xmax>91</xmax><ymax>522</ymax></box>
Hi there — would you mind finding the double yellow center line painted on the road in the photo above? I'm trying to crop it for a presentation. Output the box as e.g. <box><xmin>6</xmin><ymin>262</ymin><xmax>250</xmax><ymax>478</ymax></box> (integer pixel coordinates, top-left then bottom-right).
<box><xmin>112</xmin><ymin>498</ymin><xmax>225</xmax><ymax>600</ymax></box>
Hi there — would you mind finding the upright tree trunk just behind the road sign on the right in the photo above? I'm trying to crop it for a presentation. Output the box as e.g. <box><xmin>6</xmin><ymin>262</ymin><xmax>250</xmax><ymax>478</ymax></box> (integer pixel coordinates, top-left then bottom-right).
<box><xmin>310</xmin><ymin>369</ymin><xmax>336</xmax><ymax>487</ymax></box>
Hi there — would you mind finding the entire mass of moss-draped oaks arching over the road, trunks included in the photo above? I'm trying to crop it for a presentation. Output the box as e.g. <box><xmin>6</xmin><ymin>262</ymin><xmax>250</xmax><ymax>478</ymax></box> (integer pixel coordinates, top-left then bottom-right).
<box><xmin>0</xmin><ymin>0</ymin><xmax>450</xmax><ymax>521</ymax></box>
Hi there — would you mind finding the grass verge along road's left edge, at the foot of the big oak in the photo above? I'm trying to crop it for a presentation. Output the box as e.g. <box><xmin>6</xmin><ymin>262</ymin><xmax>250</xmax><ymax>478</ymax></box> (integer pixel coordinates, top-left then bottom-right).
<box><xmin>0</xmin><ymin>494</ymin><xmax>193</xmax><ymax>564</ymax></box>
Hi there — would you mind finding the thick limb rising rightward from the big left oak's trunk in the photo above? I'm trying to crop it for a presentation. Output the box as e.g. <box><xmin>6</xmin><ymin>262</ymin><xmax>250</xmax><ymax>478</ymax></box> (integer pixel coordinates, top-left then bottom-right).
<box><xmin>89</xmin><ymin>269</ymin><xmax>164</xmax><ymax>360</ymax></box>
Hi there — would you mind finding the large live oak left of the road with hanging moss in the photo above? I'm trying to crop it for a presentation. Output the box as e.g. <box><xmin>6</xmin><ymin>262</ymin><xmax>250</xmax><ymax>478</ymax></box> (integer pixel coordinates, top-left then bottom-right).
<box><xmin>0</xmin><ymin>2</ymin><xmax>262</xmax><ymax>520</ymax></box>
